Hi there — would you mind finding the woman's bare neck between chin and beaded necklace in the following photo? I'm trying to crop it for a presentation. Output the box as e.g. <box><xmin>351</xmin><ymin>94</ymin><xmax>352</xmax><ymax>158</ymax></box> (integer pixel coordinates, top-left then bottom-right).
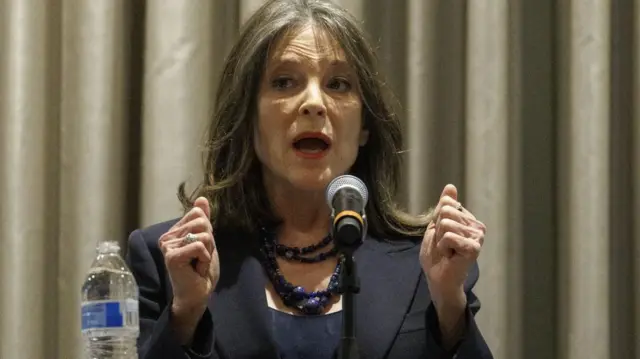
<box><xmin>265</xmin><ymin>176</ymin><xmax>331</xmax><ymax>247</ymax></box>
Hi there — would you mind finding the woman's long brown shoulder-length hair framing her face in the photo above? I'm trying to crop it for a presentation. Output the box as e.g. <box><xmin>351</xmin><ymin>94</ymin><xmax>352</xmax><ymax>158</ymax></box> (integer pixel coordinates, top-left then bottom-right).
<box><xmin>178</xmin><ymin>0</ymin><xmax>431</xmax><ymax>238</ymax></box>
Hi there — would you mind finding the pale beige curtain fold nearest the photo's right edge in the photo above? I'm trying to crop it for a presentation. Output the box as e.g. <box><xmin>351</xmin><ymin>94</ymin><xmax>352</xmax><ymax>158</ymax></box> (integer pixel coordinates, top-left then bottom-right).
<box><xmin>557</xmin><ymin>1</ymin><xmax>611</xmax><ymax>358</ymax></box>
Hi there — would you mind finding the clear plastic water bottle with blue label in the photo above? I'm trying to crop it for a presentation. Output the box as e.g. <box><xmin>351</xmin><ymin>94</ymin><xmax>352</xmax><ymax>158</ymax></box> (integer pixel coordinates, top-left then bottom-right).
<box><xmin>82</xmin><ymin>241</ymin><xmax>140</xmax><ymax>359</ymax></box>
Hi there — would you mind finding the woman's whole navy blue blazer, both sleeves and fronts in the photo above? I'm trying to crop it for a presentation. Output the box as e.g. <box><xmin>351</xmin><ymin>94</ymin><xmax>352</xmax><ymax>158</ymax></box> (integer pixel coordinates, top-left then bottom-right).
<box><xmin>126</xmin><ymin>220</ymin><xmax>493</xmax><ymax>359</ymax></box>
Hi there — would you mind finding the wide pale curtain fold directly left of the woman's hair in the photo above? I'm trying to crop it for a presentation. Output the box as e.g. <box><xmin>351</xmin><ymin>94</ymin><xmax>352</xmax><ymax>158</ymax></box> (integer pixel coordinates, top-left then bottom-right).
<box><xmin>140</xmin><ymin>0</ymin><xmax>223</xmax><ymax>225</ymax></box>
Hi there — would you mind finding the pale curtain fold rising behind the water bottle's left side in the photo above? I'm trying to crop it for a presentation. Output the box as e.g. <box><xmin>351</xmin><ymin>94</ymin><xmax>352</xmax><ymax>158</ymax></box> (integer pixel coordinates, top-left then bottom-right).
<box><xmin>57</xmin><ymin>0</ymin><xmax>131</xmax><ymax>358</ymax></box>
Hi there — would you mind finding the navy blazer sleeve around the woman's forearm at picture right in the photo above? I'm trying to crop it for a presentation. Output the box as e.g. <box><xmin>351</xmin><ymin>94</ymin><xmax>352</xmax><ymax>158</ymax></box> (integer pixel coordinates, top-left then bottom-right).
<box><xmin>425</xmin><ymin>263</ymin><xmax>493</xmax><ymax>359</ymax></box>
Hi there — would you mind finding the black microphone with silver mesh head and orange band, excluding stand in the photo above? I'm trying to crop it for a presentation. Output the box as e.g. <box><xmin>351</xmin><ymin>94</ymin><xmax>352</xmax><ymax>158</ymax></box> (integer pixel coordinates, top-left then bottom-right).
<box><xmin>326</xmin><ymin>175</ymin><xmax>369</xmax><ymax>250</ymax></box>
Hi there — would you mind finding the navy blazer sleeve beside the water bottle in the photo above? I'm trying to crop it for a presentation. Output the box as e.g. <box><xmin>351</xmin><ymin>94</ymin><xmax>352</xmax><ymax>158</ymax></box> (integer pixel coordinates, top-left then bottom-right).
<box><xmin>126</xmin><ymin>230</ymin><xmax>219</xmax><ymax>359</ymax></box>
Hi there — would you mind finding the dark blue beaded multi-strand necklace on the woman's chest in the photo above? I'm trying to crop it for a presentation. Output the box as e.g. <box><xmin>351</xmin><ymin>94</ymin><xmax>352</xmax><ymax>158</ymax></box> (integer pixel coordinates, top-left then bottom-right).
<box><xmin>260</xmin><ymin>229</ymin><xmax>342</xmax><ymax>315</ymax></box>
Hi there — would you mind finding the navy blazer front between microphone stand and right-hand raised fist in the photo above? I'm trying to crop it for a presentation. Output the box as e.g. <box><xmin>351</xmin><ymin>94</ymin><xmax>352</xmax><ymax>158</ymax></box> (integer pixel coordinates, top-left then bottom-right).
<box><xmin>355</xmin><ymin>239</ymin><xmax>421</xmax><ymax>359</ymax></box>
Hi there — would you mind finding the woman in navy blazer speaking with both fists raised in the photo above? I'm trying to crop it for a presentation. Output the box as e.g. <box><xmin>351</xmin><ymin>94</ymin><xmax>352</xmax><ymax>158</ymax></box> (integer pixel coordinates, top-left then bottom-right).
<box><xmin>128</xmin><ymin>0</ymin><xmax>491</xmax><ymax>359</ymax></box>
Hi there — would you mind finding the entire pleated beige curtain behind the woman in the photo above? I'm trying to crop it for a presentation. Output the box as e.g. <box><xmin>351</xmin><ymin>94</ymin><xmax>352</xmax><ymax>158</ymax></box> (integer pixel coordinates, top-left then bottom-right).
<box><xmin>0</xmin><ymin>0</ymin><xmax>640</xmax><ymax>359</ymax></box>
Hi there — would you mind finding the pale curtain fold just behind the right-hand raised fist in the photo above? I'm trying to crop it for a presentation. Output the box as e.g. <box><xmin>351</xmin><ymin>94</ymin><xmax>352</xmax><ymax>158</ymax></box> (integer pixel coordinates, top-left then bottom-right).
<box><xmin>462</xmin><ymin>0</ymin><xmax>516</xmax><ymax>358</ymax></box>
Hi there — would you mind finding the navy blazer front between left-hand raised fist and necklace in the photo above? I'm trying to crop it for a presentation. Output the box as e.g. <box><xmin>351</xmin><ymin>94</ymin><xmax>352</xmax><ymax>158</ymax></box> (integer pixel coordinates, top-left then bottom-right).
<box><xmin>209</xmin><ymin>233</ymin><xmax>279</xmax><ymax>359</ymax></box>
